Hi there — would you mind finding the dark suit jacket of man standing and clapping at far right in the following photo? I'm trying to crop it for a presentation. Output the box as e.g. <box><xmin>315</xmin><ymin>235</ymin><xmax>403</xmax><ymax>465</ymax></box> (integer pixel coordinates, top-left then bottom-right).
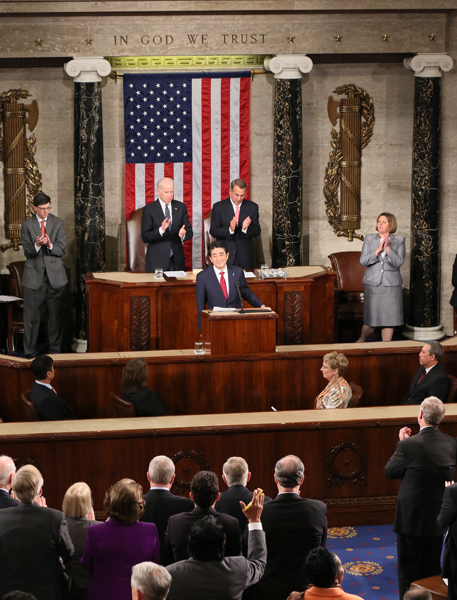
<box><xmin>385</xmin><ymin>427</ymin><xmax>457</xmax><ymax>537</ymax></box>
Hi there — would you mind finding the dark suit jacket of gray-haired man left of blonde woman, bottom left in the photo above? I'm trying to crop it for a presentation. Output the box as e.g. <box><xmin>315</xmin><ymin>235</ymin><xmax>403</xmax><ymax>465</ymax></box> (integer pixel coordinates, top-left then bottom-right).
<box><xmin>0</xmin><ymin>503</ymin><xmax>73</xmax><ymax>600</ymax></box>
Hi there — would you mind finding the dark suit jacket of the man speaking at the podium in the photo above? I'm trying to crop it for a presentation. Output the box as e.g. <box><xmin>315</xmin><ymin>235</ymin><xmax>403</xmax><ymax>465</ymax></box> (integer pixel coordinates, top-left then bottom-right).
<box><xmin>195</xmin><ymin>265</ymin><xmax>263</xmax><ymax>333</ymax></box>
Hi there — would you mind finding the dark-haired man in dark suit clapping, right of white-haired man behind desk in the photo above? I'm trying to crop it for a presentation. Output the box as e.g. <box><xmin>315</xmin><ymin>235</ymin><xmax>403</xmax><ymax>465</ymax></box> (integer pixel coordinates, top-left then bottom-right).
<box><xmin>210</xmin><ymin>179</ymin><xmax>260</xmax><ymax>269</ymax></box>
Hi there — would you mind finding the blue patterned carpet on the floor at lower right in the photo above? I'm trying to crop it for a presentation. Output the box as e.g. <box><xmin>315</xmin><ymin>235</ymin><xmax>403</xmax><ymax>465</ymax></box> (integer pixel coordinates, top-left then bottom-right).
<box><xmin>327</xmin><ymin>525</ymin><xmax>399</xmax><ymax>600</ymax></box>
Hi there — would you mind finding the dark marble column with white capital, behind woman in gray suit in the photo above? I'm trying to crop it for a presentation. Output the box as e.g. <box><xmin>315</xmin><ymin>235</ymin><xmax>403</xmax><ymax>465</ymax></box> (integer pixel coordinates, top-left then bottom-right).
<box><xmin>403</xmin><ymin>54</ymin><xmax>454</xmax><ymax>341</ymax></box>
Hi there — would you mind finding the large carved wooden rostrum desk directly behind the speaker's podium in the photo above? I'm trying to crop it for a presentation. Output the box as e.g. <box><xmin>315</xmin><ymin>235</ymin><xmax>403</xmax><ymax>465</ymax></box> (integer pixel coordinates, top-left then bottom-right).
<box><xmin>84</xmin><ymin>267</ymin><xmax>335</xmax><ymax>352</ymax></box>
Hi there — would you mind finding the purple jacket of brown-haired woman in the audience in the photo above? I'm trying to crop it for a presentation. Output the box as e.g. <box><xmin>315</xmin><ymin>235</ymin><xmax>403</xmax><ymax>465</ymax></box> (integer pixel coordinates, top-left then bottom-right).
<box><xmin>81</xmin><ymin>519</ymin><xmax>160</xmax><ymax>600</ymax></box>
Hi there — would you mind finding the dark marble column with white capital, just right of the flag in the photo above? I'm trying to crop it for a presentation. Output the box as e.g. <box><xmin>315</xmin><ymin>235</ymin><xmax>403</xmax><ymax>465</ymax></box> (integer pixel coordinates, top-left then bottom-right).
<box><xmin>265</xmin><ymin>54</ymin><xmax>313</xmax><ymax>268</ymax></box>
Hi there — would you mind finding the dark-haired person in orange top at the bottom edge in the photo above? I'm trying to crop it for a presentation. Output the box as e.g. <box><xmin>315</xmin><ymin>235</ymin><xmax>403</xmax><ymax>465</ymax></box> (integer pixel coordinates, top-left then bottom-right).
<box><xmin>287</xmin><ymin>548</ymin><xmax>363</xmax><ymax>600</ymax></box>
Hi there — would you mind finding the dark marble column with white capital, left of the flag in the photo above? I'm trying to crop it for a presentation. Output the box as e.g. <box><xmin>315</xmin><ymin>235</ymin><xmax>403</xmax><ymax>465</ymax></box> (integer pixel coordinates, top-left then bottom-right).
<box><xmin>65</xmin><ymin>57</ymin><xmax>111</xmax><ymax>351</ymax></box>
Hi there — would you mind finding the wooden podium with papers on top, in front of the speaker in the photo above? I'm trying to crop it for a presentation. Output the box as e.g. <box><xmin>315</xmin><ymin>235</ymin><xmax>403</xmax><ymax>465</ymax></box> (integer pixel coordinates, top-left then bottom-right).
<box><xmin>200</xmin><ymin>309</ymin><xmax>278</xmax><ymax>355</ymax></box>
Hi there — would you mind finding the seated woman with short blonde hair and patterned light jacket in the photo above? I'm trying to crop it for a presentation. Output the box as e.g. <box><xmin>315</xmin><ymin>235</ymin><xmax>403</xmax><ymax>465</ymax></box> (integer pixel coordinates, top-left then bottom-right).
<box><xmin>314</xmin><ymin>352</ymin><xmax>352</xmax><ymax>409</ymax></box>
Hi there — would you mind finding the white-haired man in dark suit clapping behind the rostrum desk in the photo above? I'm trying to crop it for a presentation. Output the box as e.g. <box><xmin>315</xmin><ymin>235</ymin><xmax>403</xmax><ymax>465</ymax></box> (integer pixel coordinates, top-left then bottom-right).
<box><xmin>141</xmin><ymin>177</ymin><xmax>194</xmax><ymax>273</ymax></box>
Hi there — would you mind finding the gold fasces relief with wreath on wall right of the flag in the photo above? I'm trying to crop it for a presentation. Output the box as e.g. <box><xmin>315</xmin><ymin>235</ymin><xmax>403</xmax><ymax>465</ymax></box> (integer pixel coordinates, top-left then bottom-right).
<box><xmin>324</xmin><ymin>83</ymin><xmax>375</xmax><ymax>242</ymax></box>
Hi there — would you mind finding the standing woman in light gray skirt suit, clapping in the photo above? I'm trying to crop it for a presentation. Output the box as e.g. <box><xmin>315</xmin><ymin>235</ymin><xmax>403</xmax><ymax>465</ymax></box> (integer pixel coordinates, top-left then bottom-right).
<box><xmin>357</xmin><ymin>212</ymin><xmax>405</xmax><ymax>342</ymax></box>
